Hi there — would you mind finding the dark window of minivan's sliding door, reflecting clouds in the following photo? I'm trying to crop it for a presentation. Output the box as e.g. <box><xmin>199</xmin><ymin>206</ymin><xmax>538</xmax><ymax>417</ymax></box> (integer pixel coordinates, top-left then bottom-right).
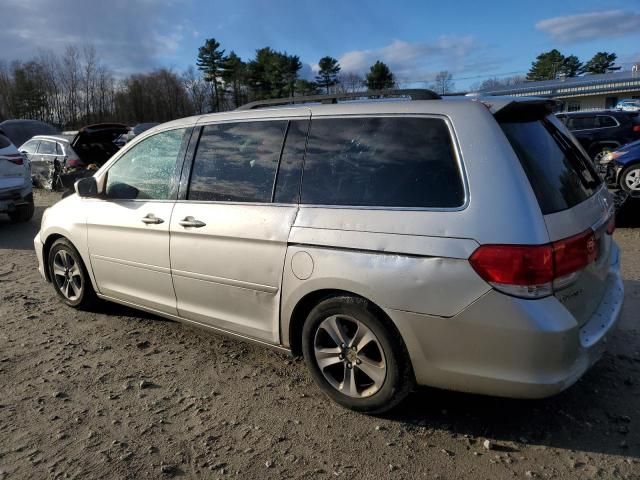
<box><xmin>188</xmin><ymin>120</ymin><xmax>287</xmax><ymax>203</ymax></box>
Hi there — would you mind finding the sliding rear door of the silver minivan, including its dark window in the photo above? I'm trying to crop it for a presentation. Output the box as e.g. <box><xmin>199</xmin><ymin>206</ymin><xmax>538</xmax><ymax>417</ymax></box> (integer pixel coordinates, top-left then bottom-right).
<box><xmin>170</xmin><ymin>116</ymin><xmax>309</xmax><ymax>343</ymax></box>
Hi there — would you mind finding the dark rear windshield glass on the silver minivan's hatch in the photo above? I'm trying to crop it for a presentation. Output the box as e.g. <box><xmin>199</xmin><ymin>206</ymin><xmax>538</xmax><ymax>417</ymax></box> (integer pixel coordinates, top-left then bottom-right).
<box><xmin>501</xmin><ymin>119</ymin><xmax>601</xmax><ymax>215</ymax></box>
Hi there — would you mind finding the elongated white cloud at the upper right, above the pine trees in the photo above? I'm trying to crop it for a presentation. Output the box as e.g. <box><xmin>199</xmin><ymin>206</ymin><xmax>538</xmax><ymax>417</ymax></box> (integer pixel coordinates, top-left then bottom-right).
<box><xmin>536</xmin><ymin>10</ymin><xmax>640</xmax><ymax>43</ymax></box>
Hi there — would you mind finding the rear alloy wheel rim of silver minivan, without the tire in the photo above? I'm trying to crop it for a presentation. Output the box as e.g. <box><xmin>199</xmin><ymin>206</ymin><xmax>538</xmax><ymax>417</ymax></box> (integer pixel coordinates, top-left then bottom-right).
<box><xmin>314</xmin><ymin>315</ymin><xmax>387</xmax><ymax>398</ymax></box>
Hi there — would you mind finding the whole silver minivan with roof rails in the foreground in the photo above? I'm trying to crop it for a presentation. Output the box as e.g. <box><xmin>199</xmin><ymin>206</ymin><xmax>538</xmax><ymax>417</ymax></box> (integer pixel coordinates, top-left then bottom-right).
<box><xmin>35</xmin><ymin>94</ymin><xmax>623</xmax><ymax>413</ymax></box>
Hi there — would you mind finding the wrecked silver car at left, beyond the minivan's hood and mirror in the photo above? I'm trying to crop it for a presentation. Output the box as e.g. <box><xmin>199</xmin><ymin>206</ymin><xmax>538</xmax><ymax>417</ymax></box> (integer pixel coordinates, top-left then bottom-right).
<box><xmin>20</xmin><ymin>135</ymin><xmax>86</xmax><ymax>190</ymax></box>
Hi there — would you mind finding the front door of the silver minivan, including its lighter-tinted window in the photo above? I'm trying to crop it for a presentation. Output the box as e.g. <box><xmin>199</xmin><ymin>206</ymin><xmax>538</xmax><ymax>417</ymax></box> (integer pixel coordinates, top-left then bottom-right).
<box><xmin>85</xmin><ymin>129</ymin><xmax>190</xmax><ymax>315</ymax></box>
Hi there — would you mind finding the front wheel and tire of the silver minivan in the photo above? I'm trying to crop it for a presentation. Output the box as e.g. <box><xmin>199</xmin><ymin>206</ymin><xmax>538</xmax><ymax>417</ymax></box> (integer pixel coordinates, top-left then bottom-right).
<box><xmin>47</xmin><ymin>238</ymin><xmax>97</xmax><ymax>310</ymax></box>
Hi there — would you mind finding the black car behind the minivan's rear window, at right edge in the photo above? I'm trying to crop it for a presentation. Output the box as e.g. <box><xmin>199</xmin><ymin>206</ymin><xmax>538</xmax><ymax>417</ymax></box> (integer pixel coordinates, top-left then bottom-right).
<box><xmin>557</xmin><ymin>110</ymin><xmax>640</xmax><ymax>164</ymax></box>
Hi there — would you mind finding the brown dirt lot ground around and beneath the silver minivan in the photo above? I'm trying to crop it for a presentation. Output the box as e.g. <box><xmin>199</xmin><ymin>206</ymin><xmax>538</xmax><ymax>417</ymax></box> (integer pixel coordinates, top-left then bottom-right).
<box><xmin>0</xmin><ymin>193</ymin><xmax>640</xmax><ymax>479</ymax></box>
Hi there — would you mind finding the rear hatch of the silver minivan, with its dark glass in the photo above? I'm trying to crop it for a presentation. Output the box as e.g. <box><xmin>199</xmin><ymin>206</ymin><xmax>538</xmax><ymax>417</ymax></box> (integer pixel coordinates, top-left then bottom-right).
<box><xmin>495</xmin><ymin>102</ymin><xmax>613</xmax><ymax>326</ymax></box>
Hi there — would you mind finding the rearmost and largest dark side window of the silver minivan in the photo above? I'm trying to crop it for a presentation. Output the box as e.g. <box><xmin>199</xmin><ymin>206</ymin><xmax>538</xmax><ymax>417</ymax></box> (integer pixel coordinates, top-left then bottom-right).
<box><xmin>301</xmin><ymin>117</ymin><xmax>464</xmax><ymax>208</ymax></box>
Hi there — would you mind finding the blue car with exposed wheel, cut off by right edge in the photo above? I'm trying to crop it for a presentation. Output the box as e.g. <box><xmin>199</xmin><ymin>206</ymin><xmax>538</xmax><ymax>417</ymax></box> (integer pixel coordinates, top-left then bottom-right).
<box><xmin>600</xmin><ymin>140</ymin><xmax>640</xmax><ymax>197</ymax></box>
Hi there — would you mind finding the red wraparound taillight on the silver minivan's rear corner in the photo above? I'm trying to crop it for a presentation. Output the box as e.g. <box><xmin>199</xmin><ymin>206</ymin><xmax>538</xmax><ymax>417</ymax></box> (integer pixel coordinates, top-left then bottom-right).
<box><xmin>469</xmin><ymin>229</ymin><xmax>598</xmax><ymax>298</ymax></box>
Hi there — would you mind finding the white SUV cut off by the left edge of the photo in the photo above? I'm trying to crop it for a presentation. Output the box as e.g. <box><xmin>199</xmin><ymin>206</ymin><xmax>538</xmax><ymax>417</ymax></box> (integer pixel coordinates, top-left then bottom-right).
<box><xmin>0</xmin><ymin>130</ymin><xmax>34</xmax><ymax>222</ymax></box>
